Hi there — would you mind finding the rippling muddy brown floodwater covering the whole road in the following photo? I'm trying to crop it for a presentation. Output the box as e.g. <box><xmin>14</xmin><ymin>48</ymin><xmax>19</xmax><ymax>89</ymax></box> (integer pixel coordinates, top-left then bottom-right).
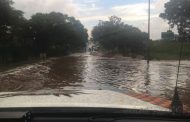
<box><xmin>0</xmin><ymin>54</ymin><xmax>190</xmax><ymax>107</ymax></box>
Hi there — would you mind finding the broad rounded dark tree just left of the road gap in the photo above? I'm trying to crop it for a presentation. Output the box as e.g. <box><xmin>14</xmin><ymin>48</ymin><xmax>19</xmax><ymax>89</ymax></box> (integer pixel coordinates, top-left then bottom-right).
<box><xmin>30</xmin><ymin>12</ymin><xmax>88</xmax><ymax>54</ymax></box>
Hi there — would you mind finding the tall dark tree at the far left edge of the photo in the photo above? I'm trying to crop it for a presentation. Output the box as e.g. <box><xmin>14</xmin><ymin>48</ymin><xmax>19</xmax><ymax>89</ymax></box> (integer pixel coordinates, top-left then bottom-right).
<box><xmin>0</xmin><ymin>0</ymin><xmax>26</xmax><ymax>63</ymax></box>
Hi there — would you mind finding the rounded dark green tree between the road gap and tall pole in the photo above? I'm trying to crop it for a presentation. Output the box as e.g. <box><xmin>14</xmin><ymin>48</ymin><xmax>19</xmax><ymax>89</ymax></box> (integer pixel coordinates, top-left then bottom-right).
<box><xmin>92</xmin><ymin>16</ymin><xmax>148</xmax><ymax>55</ymax></box>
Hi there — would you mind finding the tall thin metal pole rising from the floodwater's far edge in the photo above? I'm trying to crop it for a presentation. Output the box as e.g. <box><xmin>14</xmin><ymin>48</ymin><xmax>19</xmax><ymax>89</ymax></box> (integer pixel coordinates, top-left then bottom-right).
<box><xmin>147</xmin><ymin>0</ymin><xmax>150</xmax><ymax>64</ymax></box>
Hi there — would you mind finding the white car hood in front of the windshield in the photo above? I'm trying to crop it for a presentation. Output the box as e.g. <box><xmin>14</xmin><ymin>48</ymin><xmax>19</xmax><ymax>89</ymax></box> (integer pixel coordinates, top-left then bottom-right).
<box><xmin>0</xmin><ymin>90</ymin><xmax>170</xmax><ymax>111</ymax></box>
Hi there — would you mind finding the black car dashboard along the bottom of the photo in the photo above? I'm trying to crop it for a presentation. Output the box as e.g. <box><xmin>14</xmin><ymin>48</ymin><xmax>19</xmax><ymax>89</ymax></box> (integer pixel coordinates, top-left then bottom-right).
<box><xmin>0</xmin><ymin>108</ymin><xmax>190</xmax><ymax>122</ymax></box>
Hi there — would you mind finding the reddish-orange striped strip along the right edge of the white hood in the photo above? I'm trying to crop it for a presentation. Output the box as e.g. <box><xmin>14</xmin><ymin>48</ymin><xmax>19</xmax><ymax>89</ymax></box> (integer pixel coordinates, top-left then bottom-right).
<box><xmin>127</xmin><ymin>93</ymin><xmax>190</xmax><ymax>112</ymax></box>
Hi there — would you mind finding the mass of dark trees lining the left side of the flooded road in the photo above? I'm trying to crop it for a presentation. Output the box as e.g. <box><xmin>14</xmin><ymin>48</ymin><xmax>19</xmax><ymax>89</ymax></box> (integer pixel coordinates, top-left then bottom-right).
<box><xmin>0</xmin><ymin>0</ymin><xmax>88</xmax><ymax>64</ymax></box>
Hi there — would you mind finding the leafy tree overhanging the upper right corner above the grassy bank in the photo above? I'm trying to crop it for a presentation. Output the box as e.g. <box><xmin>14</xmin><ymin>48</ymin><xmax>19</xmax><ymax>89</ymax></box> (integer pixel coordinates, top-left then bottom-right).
<box><xmin>160</xmin><ymin>0</ymin><xmax>190</xmax><ymax>39</ymax></box>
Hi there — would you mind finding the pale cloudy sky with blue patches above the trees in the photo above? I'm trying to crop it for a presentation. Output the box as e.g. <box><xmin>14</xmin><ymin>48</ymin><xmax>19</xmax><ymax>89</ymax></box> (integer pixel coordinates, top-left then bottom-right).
<box><xmin>13</xmin><ymin>0</ymin><xmax>175</xmax><ymax>39</ymax></box>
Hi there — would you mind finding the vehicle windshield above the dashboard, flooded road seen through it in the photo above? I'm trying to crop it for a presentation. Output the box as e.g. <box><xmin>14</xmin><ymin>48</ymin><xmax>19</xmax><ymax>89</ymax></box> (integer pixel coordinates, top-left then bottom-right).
<box><xmin>0</xmin><ymin>0</ymin><xmax>190</xmax><ymax>112</ymax></box>
